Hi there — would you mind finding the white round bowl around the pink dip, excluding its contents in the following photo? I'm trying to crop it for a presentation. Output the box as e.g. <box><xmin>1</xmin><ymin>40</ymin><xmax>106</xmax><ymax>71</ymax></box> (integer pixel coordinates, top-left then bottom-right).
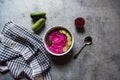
<box><xmin>44</xmin><ymin>26</ymin><xmax>74</xmax><ymax>56</ymax></box>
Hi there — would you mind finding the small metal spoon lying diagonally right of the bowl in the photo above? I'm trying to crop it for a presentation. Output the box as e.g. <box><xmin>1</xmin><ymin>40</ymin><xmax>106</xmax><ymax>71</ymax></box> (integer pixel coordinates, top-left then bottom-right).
<box><xmin>73</xmin><ymin>36</ymin><xmax>92</xmax><ymax>59</ymax></box>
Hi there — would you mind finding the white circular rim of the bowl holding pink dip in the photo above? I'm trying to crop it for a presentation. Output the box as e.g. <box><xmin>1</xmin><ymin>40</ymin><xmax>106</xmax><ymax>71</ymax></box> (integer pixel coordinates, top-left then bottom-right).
<box><xmin>43</xmin><ymin>26</ymin><xmax>74</xmax><ymax>56</ymax></box>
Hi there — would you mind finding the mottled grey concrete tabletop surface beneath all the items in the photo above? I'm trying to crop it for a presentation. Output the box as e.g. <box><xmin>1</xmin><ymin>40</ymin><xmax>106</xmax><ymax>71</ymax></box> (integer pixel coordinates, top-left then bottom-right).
<box><xmin>0</xmin><ymin>0</ymin><xmax>120</xmax><ymax>80</ymax></box>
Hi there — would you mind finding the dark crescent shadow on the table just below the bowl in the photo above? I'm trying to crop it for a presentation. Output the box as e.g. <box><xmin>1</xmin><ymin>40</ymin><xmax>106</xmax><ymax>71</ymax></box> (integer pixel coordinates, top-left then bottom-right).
<box><xmin>50</xmin><ymin>50</ymin><xmax>73</xmax><ymax>65</ymax></box>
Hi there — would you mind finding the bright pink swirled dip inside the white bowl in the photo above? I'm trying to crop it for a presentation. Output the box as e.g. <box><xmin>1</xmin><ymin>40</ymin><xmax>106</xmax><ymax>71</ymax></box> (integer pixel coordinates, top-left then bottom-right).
<box><xmin>46</xmin><ymin>30</ymin><xmax>67</xmax><ymax>54</ymax></box>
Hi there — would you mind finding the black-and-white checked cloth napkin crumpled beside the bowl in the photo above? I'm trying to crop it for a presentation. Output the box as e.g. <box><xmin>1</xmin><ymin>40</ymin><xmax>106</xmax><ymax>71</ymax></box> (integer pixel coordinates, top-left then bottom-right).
<box><xmin>0</xmin><ymin>21</ymin><xmax>51</xmax><ymax>80</ymax></box>
